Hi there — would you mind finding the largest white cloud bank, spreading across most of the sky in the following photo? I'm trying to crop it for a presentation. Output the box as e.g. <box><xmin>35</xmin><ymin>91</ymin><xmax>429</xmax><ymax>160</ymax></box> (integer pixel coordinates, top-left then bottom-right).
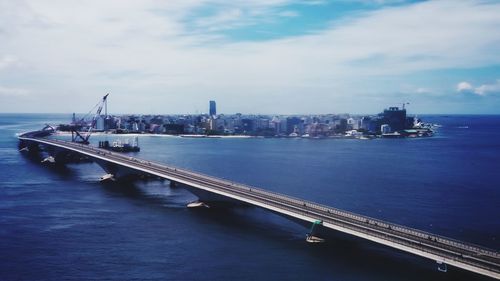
<box><xmin>0</xmin><ymin>0</ymin><xmax>500</xmax><ymax>112</ymax></box>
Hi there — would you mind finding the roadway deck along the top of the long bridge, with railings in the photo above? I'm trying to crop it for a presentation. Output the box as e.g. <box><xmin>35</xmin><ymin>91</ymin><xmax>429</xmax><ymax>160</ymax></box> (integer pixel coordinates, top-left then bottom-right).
<box><xmin>24</xmin><ymin>137</ymin><xmax>500</xmax><ymax>258</ymax></box>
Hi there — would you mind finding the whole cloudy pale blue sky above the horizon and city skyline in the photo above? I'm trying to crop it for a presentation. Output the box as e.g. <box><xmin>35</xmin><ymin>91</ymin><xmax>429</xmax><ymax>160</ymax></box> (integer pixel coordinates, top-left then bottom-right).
<box><xmin>0</xmin><ymin>0</ymin><xmax>500</xmax><ymax>114</ymax></box>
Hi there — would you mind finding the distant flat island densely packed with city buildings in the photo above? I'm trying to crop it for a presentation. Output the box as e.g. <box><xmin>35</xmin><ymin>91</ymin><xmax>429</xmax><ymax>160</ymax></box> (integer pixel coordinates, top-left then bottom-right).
<box><xmin>56</xmin><ymin>100</ymin><xmax>435</xmax><ymax>139</ymax></box>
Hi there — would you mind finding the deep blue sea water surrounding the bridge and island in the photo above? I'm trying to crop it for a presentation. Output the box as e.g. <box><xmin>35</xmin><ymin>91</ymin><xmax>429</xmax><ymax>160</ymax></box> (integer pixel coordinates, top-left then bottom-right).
<box><xmin>0</xmin><ymin>114</ymin><xmax>500</xmax><ymax>281</ymax></box>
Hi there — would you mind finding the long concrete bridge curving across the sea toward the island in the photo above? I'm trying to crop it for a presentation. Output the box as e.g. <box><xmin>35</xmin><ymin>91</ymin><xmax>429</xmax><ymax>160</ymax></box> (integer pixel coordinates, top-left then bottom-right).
<box><xmin>19</xmin><ymin>133</ymin><xmax>500</xmax><ymax>279</ymax></box>
